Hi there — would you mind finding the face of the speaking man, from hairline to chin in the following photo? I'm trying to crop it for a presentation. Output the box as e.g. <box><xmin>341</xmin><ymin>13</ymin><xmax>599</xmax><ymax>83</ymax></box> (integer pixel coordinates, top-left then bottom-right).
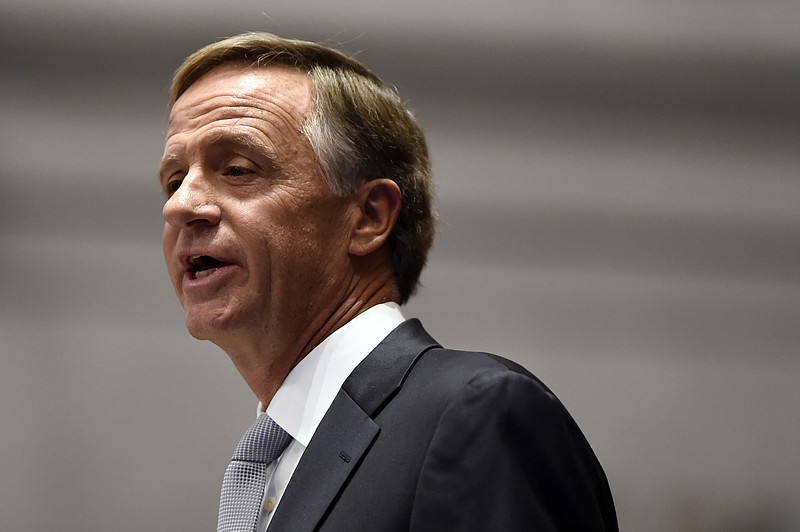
<box><xmin>160</xmin><ymin>65</ymin><xmax>353</xmax><ymax>356</ymax></box>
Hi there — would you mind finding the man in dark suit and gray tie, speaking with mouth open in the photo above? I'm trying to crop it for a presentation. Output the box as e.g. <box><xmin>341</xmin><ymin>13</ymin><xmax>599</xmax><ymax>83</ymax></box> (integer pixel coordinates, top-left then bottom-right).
<box><xmin>160</xmin><ymin>34</ymin><xmax>617</xmax><ymax>532</ymax></box>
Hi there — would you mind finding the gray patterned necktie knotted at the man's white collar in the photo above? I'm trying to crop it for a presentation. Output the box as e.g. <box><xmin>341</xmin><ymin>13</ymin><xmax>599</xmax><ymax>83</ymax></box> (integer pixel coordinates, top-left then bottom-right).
<box><xmin>217</xmin><ymin>414</ymin><xmax>292</xmax><ymax>532</ymax></box>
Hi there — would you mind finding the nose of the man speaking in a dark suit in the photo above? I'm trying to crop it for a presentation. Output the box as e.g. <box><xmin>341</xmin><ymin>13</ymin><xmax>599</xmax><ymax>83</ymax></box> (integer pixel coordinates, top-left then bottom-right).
<box><xmin>162</xmin><ymin>170</ymin><xmax>222</xmax><ymax>228</ymax></box>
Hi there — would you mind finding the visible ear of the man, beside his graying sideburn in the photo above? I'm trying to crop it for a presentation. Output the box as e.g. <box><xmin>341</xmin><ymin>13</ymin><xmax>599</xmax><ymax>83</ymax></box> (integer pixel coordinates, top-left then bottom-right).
<box><xmin>349</xmin><ymin>179</ymin><xmax>402</xmax><ymax>257</ymax></box>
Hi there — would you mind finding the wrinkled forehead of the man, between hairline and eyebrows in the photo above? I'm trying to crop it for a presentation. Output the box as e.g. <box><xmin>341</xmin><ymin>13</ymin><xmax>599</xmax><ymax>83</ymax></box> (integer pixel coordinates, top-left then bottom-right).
<box><xmin>167</xmin><ymin>63</ymin><xmax>312</xmax><ymax>136</ymax></box>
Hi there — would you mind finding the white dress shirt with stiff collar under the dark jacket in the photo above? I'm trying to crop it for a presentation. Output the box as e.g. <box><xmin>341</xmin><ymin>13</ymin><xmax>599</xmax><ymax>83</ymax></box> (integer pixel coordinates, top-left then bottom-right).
<box><xmin>256</xmin><ymin>303</ymin><xmax>405</xmax><ymax>531</ymax></box>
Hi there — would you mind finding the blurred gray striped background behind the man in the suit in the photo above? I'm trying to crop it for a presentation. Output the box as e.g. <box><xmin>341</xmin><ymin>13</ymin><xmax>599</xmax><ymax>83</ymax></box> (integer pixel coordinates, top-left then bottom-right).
<box><xmin>0</xmin><ymin>0</ymin><xmax>800</xmax><ymax>532</ymax></box>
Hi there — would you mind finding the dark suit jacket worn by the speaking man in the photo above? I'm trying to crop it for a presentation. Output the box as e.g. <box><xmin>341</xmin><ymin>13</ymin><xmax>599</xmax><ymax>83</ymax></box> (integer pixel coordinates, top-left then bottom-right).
<box><xmin>269</xmin><ymin>320</ymin><xmax>618</xmax><ymax>532</ymax></box>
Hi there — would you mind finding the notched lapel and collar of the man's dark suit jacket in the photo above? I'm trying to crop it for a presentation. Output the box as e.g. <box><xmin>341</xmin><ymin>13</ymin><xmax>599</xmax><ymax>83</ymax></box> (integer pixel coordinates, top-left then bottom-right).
<box><xmin>269</xmin><ymin>320</ymin><xmax>438</xmax><ymax>532</ymax></box>
